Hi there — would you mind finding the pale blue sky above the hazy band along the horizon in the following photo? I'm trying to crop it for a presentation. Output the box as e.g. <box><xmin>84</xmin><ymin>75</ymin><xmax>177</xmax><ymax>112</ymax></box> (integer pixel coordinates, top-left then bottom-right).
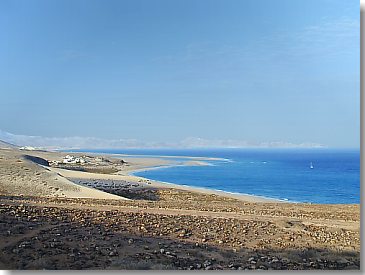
<box><xmin>0</xmin><ymin>0</ymin><xmax>360</xmax><ymax>147</ymax></box>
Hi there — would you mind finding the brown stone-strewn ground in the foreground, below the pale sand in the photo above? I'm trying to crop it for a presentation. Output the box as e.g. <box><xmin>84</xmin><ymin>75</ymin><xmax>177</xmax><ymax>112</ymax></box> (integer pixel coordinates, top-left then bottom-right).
<box><xmin>0</xmin><ymin>189</ymin><xmax>360</xmax><ymax>270</ymax></box>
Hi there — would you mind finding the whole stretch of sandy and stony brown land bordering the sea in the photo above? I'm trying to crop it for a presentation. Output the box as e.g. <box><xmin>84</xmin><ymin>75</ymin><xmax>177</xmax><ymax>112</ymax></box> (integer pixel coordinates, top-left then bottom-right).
<box><xmin>0</xmin><ymin>148</ymin><xmax>360</xmax><ymax>270</ymax></box>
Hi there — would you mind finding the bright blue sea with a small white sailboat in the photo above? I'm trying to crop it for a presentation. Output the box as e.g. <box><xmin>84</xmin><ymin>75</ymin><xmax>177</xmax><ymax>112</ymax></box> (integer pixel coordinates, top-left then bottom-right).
<box><xmin>65</xmin><ymin>149</ymin><xmax>360</xmax><ymax>204</ymax></box>
